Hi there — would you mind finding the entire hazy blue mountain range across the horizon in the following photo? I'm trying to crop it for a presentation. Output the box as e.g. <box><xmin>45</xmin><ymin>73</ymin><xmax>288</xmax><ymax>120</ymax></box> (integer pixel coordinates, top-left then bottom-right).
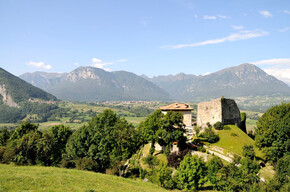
<box><xmin>20</xmin><ymin>64</ymin><xmax>290</xmax><ymax>101</ymax></box>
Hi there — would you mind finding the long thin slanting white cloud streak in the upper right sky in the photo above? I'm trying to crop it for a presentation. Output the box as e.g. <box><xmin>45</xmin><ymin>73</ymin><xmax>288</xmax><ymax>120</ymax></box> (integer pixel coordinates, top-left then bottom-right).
<box><xmin>161</xmin><ymin>29</ymin><xmax>268</xmax><ymax>49</ymax></box>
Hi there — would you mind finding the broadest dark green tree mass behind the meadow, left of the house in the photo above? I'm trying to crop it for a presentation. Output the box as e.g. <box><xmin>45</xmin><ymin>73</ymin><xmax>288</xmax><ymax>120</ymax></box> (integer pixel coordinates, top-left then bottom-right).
<box><xmin>66</xmin><ymin>110</ymin><xmax>141</xmax><ymax>172</ymax></box>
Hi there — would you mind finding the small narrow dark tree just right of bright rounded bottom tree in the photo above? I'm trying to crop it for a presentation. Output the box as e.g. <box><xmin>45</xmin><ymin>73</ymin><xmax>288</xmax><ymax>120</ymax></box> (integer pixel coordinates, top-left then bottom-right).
<box><xmin>206</xmin><ymin>156</ymin><xmax>223</xmax><ymax>188</ymax></box>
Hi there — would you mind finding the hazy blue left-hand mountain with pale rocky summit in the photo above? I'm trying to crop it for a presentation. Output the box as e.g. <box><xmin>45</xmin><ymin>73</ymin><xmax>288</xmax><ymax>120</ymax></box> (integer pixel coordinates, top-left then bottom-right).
<box><xmin>20</xmin><ymin>67</ymin><xmax>171</xmax><ymax>101</ymax></box>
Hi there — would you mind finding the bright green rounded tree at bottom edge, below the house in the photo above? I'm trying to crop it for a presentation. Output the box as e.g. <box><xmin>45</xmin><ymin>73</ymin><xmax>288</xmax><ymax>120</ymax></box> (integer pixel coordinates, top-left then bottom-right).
<box><xmin>175</xmin><ymin>154</ymin><xmax>206</xmax><ymax>190</ymax></box>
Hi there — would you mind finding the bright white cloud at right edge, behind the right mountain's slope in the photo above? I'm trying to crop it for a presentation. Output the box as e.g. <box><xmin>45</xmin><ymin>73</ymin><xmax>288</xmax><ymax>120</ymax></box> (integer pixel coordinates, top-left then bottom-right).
<box><xmin>252</xmin><ymin>58</ymin><xmax>290</xmax><ymax>85</ymax></box>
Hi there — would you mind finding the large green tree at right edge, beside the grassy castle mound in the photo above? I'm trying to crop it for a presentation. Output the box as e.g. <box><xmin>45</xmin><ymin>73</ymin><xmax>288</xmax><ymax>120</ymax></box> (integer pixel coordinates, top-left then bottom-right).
<box><xmin>255</xmin><ymin>103</ymin><xmax>290</xmax><ymax>162</ymax></box>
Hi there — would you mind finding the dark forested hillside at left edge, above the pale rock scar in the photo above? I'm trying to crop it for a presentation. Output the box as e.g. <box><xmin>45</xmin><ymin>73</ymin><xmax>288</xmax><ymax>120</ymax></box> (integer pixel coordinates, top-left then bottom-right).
<box><xmin>0</xmin><ymin>68</ymin><xmax>56</xmax><ymax>103</ymax></box>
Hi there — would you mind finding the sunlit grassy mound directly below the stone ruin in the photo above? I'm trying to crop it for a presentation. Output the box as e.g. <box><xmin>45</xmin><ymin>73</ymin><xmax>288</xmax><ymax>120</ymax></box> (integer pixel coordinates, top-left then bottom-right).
<box><xmin>213</xmin><ymin>125</ymin><xmax>263</xmax><ymax>157</ymax></box>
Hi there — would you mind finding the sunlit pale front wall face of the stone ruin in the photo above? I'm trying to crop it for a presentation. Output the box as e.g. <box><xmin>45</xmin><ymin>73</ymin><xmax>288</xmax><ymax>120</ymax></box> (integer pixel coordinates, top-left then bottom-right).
<box><xmin>196</xmin><ymin>99</ymin><xmax>222</xmax><ymax>127</ymax></box>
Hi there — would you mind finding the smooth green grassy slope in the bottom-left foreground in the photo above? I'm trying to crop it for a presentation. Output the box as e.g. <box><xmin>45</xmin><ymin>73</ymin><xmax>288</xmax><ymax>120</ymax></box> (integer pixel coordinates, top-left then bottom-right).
<box><xmin>0</xmin><ymin>164</ymin><xmax>171</xmax><ymax>192</ymax></box>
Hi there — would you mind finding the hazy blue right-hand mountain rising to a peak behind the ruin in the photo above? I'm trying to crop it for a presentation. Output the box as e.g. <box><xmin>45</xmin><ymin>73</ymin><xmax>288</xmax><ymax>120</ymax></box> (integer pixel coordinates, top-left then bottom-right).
<box><xmin>143</xmin><ymin>63</ymin><xmax>290</xmax><ymax>101</ymax></box>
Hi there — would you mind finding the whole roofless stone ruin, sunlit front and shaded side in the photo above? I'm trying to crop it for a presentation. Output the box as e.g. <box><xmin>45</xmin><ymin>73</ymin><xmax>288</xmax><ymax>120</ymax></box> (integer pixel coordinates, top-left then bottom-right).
<box><xmin>196</xmin><ymin>98</ymin><xmax>241</xmax><ymax>128</ymax></box>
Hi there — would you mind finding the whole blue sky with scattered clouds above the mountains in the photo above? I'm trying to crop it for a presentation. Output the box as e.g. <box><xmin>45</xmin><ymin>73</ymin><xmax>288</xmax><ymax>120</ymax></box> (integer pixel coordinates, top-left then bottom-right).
<box><xmin>0</xmin><ymin>0</ymin><xmax>290</xmax><ymax>84</ymax></box>
